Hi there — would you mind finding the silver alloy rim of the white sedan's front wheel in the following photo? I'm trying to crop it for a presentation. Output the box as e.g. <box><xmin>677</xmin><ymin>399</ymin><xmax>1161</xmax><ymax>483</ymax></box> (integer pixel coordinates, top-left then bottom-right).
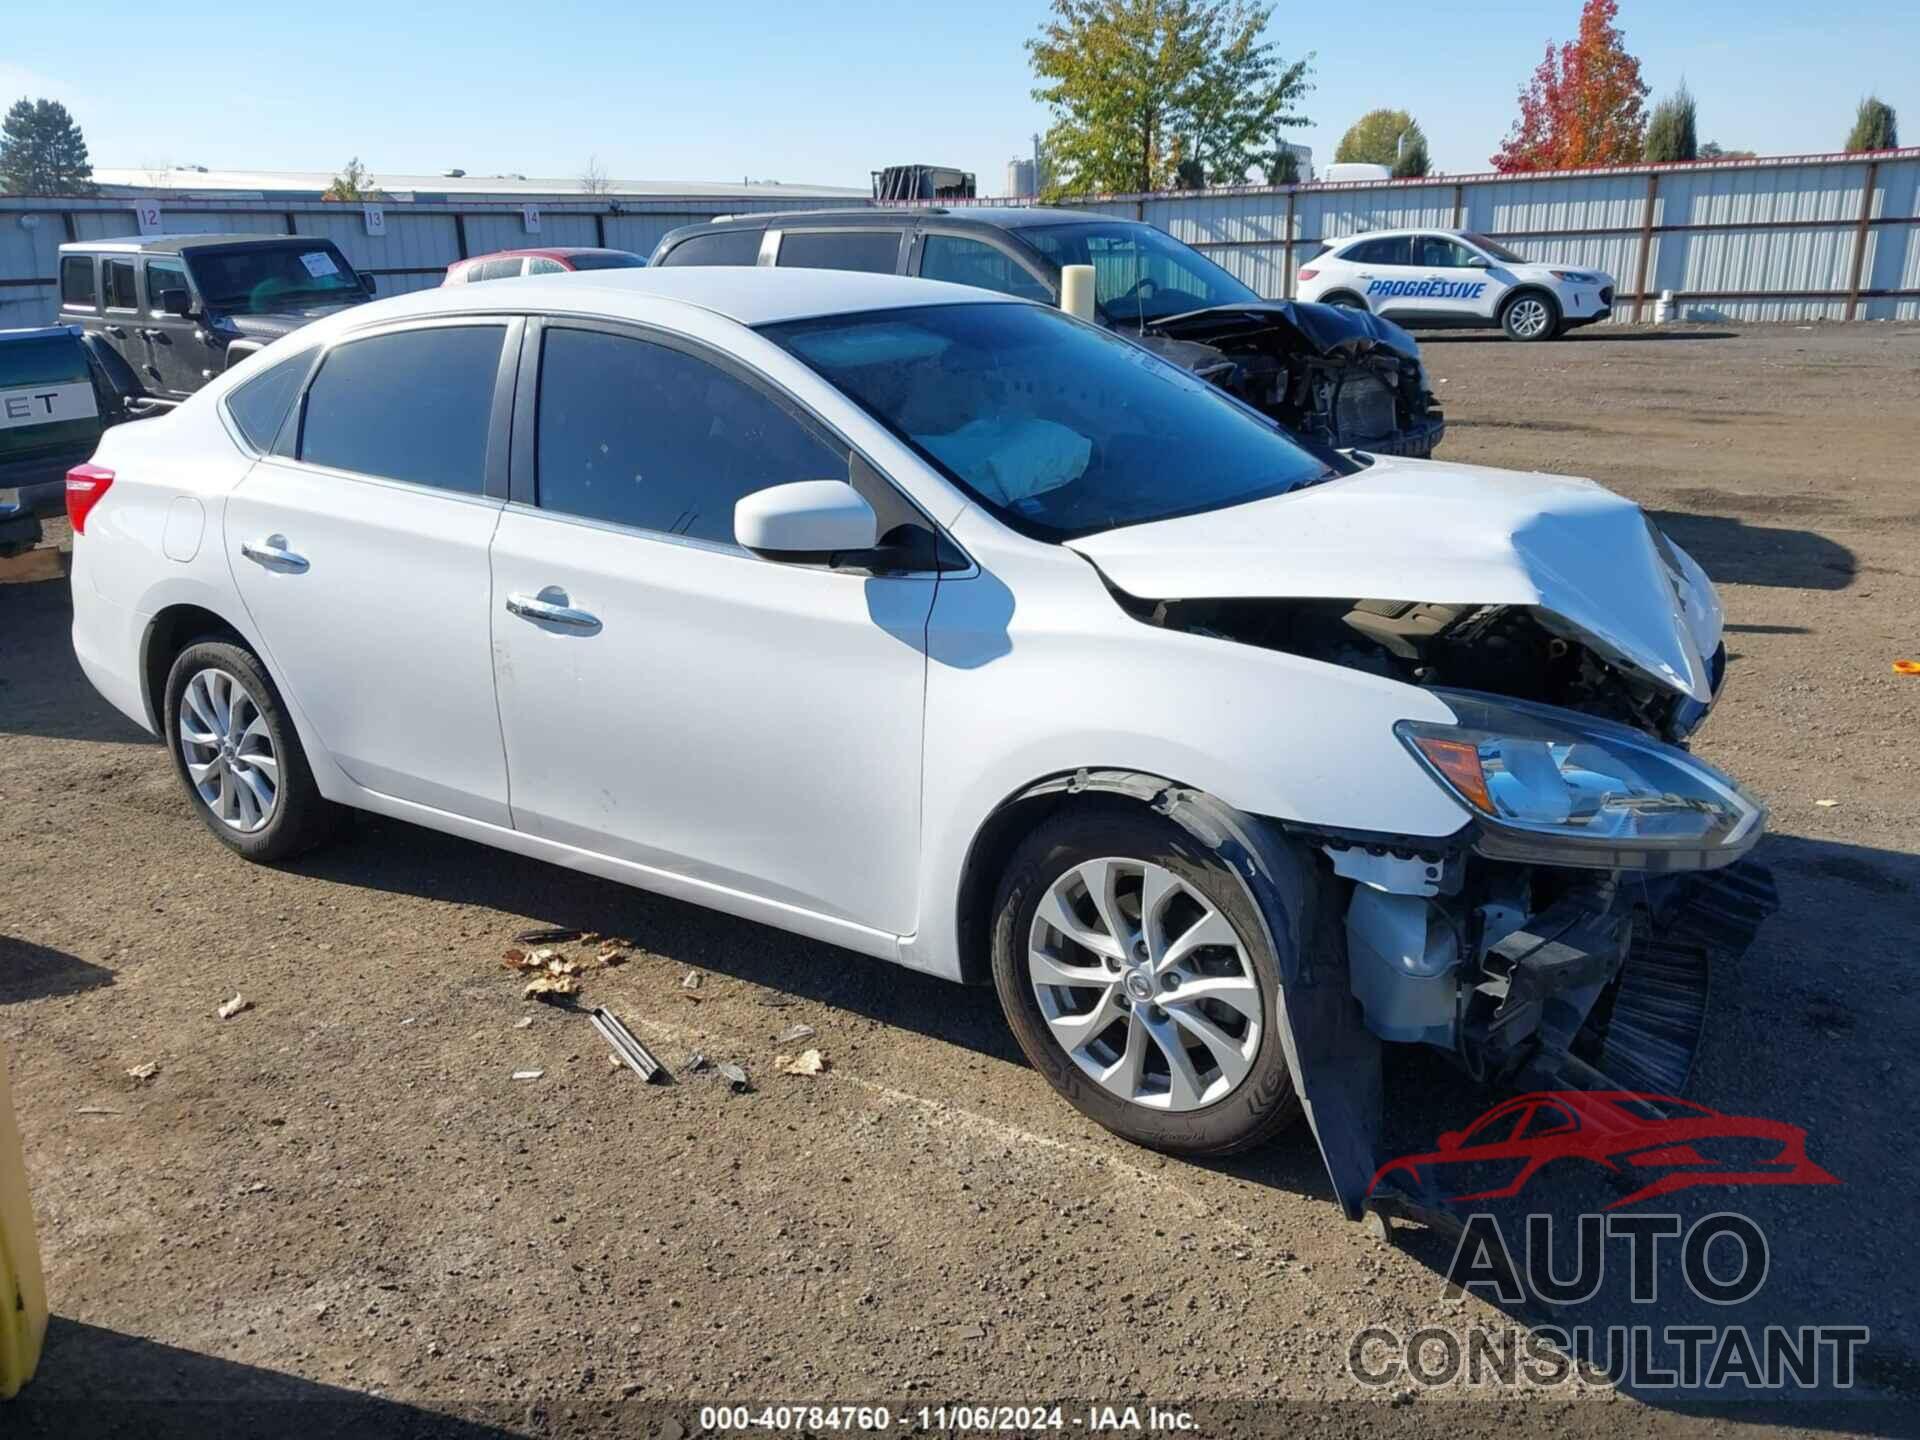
<box><xmin>1027</xmin><ymin>858</ymin><xmax>1263</xmax><ymax>1112</ymax></box>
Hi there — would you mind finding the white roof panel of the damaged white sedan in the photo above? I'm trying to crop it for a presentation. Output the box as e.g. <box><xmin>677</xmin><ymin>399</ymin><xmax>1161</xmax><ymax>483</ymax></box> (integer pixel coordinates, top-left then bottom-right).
<box><xmin>353</xmin><ymin>265</ymin><xmax>1025</xmax><ymax>324</ymax></box>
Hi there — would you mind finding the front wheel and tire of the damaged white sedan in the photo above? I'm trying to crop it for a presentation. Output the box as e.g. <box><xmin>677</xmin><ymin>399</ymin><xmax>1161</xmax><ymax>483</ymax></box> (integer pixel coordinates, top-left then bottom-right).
<box><xmin>993</xmin><ymin>801</ymin><xmax>1300</xmax><ymax>1156</ymax></box>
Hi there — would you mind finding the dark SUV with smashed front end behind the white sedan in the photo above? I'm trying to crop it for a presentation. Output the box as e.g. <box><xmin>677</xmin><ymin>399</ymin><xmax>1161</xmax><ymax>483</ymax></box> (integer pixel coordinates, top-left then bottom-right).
<box><xmin>651</xmin><ymin>207</ymin><xmax>1446</xmax><ymax>459</ymax></box>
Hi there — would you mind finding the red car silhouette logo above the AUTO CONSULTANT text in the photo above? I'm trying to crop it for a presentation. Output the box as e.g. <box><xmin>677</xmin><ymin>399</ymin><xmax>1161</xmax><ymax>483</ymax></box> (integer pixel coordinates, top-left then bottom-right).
<box><xmin>1373</xmin><ymin>1091</ymin><xmax>1839</xmax><ymax>1210</ymax></box>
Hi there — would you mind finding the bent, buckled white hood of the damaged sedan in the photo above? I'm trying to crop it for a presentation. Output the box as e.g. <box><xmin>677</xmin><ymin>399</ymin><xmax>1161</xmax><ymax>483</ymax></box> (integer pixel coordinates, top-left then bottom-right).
<box><xmin>1069</xmin><ymin>459</ymin><xmax>1722</xmax><ymax>703</ymax></box>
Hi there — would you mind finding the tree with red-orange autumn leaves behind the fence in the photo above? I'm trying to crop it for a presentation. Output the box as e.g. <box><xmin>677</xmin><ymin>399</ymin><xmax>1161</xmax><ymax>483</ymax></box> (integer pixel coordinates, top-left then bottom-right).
<box><xmin>1494</xmin><ymin>0</ymin><xmax>1647</xmax><ymax>175</ymax></box>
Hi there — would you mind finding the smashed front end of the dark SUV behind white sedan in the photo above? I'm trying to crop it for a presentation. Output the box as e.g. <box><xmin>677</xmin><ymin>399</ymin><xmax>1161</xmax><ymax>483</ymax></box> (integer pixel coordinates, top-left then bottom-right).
<box><xmin>1139</xmin><ymin>300</ymin><xmax>1446</xmax><ymax>459</ymax></box>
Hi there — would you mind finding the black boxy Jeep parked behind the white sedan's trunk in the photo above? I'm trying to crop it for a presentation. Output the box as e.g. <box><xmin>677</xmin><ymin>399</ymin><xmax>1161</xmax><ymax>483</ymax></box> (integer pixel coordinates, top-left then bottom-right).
<box><xmin>60</xmin><ymin>234</ymin><xmax>372</xmax><ymax>401</ymax></box>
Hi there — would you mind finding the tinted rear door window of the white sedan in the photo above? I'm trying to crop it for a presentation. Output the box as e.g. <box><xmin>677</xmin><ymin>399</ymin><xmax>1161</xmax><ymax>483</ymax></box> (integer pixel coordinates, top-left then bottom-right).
<box><xmin>300</xmin><ymin>324</ymin><xmax>505</xmax><ymax>495</ymax></box>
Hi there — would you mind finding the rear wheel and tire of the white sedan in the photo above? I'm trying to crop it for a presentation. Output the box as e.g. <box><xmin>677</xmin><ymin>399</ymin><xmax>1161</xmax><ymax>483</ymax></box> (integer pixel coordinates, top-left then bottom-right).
<box><xmin>163</xmin><ymin>639</ymin><xmax>346</xmax><ymax>864</ymax></box>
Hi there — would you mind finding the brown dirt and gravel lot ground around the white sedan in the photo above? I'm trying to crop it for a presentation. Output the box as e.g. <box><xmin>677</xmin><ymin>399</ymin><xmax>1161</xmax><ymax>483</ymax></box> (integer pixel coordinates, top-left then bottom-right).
<box><xmin>0</xmin><ymin>324</ymin><xmax>1920</xmax><ymax>1436</ymax></box>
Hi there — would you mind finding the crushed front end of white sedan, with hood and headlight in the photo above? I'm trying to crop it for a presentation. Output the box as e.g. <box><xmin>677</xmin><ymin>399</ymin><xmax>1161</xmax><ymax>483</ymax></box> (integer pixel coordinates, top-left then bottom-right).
<box><xmin>1073</xmin><ymin>461</ymin><xmax>1776</xmax><ymax>1219</ymax></box>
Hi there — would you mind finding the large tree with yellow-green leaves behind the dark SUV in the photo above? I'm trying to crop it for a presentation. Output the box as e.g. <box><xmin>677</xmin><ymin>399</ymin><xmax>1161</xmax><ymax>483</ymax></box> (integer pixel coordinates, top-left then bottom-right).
<box><xmin>1027</xmin><ymin>0</ymin><xmax>1311</xmax><ymax>198</ymax></box>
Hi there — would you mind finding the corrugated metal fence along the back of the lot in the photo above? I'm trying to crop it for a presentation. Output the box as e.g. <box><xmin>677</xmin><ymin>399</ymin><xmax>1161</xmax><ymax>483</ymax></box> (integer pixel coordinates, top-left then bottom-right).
<box><xmin>0</xmin><ymin>148</ymin><xmax>1920</xmax><ymax>324</ymax></box>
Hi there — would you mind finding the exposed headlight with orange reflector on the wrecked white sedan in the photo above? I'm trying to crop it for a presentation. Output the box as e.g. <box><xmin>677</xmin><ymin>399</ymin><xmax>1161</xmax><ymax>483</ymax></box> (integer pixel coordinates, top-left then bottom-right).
<box><xmin>1394</xmin><ymin>689</ymin><xmax>1766</xmax><ymax>872</ymax></box>
